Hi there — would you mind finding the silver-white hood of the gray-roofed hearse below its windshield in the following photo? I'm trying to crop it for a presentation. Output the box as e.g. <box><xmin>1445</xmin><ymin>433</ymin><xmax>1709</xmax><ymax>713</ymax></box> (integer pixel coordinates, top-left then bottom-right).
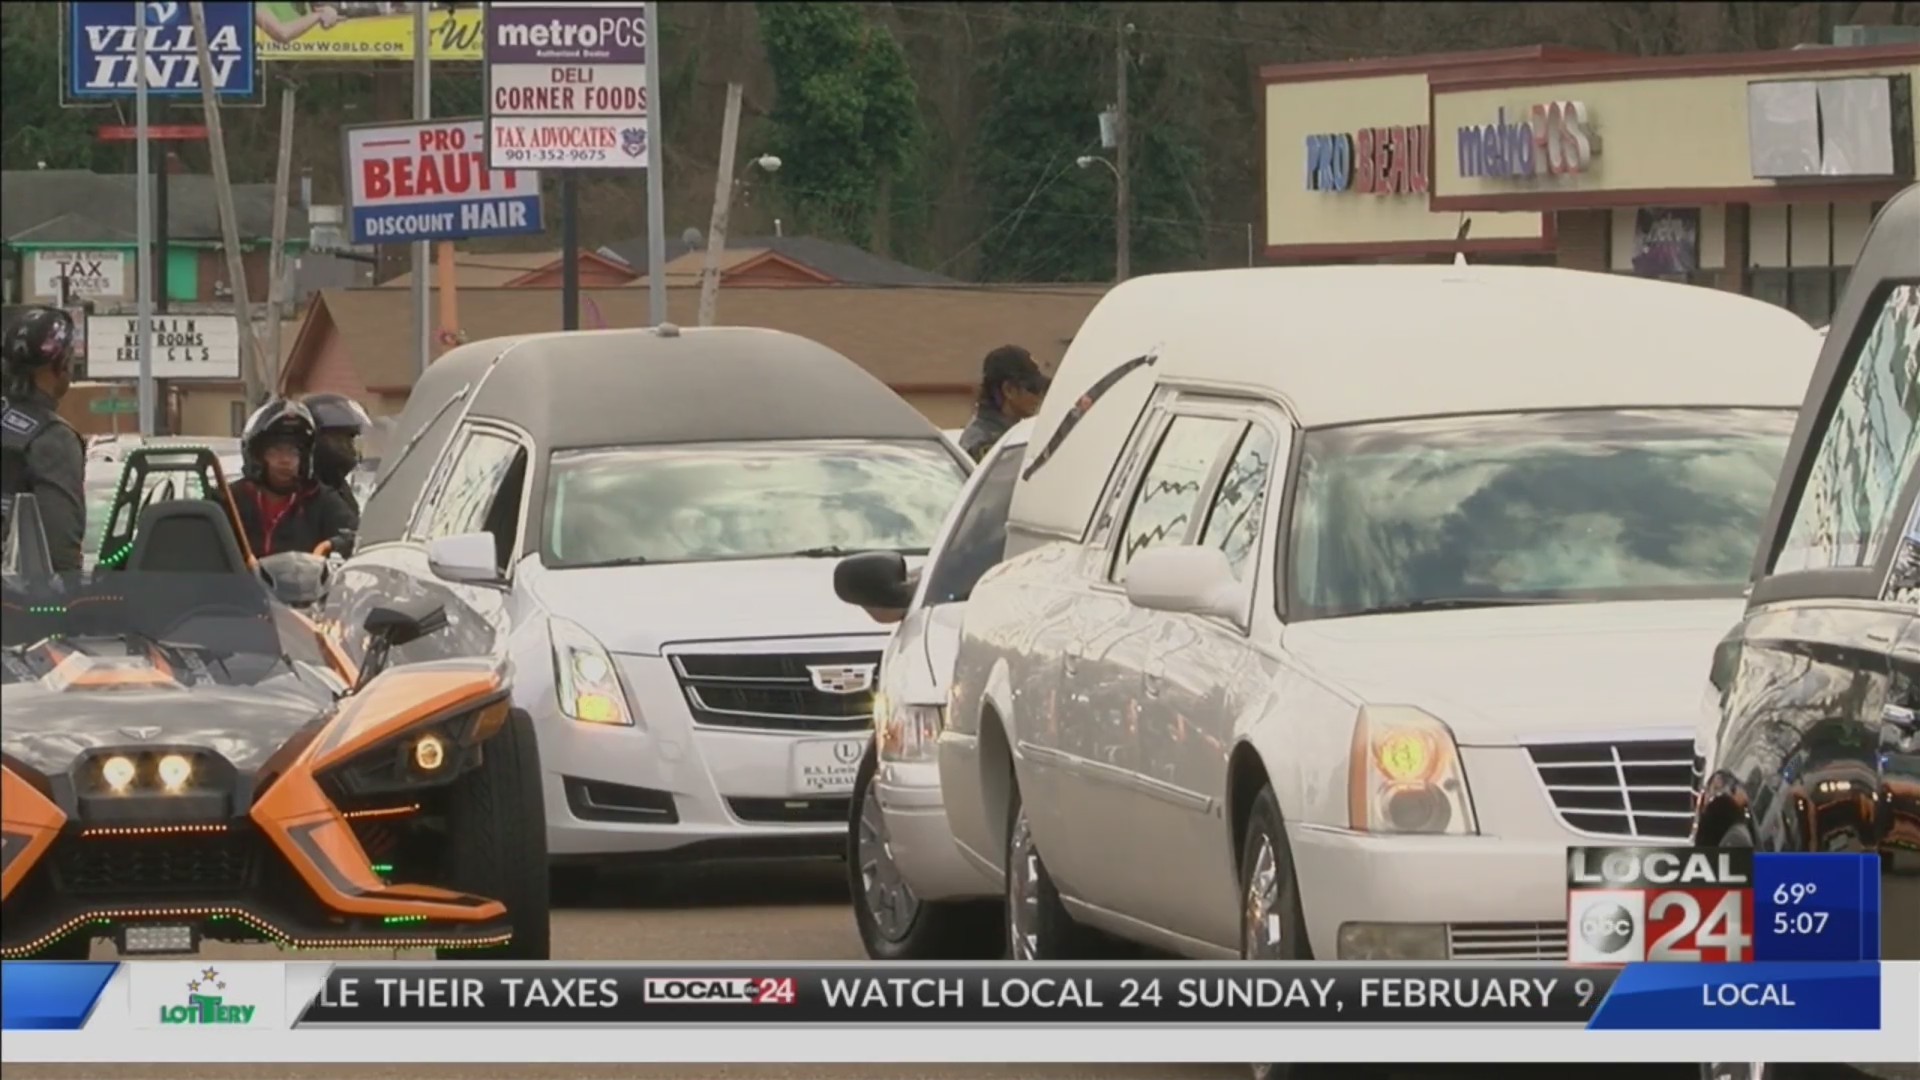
<box><xmin>528</xmin><ymin>559</ymin><xmax>918</xmax><ymax>655</ymax></box>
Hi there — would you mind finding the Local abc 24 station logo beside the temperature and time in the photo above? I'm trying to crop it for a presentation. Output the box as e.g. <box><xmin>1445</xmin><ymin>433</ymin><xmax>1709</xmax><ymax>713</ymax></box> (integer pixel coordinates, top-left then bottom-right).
<box><xmin>1567</xmin><ymin>847</ymin><xmax>1753</xmax><ymax>965</ymax></box>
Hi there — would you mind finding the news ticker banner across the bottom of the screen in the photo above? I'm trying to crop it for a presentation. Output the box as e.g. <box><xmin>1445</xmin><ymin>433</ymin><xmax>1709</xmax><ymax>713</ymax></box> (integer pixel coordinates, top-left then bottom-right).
<box><xmin>0</xmin><ymin>961</ymin><xmax>1920</xmax><ymax>1063</ymax></box>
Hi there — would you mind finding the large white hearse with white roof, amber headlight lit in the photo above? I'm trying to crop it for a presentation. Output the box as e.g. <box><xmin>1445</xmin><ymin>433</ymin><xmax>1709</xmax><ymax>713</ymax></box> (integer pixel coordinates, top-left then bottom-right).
<box><xmin>939</xmin><ymin>267</ymin><xmax>1818</xmax><ymax>959</ymax></box>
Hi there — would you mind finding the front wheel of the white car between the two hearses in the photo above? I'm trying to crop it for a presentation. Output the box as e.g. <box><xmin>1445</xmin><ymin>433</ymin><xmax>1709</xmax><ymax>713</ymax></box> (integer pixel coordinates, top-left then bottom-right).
<box><xmin>856</xmin><ymin>748</ymin><xmax>1006</xmax><ymax>961</ymax></box>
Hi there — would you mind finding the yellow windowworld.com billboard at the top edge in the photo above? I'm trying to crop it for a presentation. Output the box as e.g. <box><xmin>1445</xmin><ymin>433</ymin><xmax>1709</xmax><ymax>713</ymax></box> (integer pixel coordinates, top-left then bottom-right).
<box><xmin>255</xmin><ymin>2</ymin><xmax>486</xmax><ymax>63</ymax></box>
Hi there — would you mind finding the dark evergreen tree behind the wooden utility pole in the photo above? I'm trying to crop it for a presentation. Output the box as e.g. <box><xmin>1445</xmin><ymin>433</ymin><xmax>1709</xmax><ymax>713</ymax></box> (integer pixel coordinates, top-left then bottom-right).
<box><xmin>973</xmin><ymin>4</ymin><xmax>1210</xmax><ymax>281</ymax></box>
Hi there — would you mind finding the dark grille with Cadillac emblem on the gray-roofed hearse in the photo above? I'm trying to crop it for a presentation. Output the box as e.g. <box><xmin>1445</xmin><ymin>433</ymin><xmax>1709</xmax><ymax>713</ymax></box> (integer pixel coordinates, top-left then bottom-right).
<box><xmin>674</xmin><ymin>651</ymin><xmax>879</xmax><ymax>732</ymax></box>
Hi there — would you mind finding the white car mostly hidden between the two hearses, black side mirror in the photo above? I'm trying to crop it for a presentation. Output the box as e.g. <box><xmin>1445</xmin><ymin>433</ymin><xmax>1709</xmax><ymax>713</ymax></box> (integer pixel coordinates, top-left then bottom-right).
<box><xmin>833</xmin><ymin>421</ymin><xmax>1033</xmax><ymax>961</ymax></box>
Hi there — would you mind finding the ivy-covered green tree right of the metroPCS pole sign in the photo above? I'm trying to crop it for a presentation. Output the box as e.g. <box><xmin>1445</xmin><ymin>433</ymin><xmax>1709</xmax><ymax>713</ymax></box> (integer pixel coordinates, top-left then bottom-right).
<box><xmin>756</xmin><ymin>2</ymin><xmax>924</xmax><ymax>244</ymax></box>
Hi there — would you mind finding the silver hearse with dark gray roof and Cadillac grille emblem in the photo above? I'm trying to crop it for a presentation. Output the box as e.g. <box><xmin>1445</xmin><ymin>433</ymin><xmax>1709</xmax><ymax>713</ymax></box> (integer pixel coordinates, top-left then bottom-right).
<box><xmin>324</xmin><ymin>319</ymin><xmax>970</xmax><ymax>890</ymax></box>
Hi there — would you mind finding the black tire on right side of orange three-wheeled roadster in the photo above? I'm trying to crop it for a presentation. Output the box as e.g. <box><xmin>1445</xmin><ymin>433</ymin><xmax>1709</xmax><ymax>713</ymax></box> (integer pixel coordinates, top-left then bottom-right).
<box><xmin>438</xmin><ymin>709</ymin><xmax>553</xmax><ymax>961</ymax></box>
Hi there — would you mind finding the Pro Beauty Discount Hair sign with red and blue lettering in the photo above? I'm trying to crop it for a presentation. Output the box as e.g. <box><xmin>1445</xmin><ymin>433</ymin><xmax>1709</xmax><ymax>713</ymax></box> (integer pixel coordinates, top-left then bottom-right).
<box><xmin>346</xmin><ymin>119</ymin><xmax>545</xmax><ymax>244</ymax></box>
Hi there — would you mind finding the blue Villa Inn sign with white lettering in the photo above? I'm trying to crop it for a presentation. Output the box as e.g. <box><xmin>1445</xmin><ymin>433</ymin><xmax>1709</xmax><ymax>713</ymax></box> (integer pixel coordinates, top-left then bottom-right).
<box><xmin>60</xmin><ymin>0</ymin><xmax>257</xmax><ymax>106</ymax></box>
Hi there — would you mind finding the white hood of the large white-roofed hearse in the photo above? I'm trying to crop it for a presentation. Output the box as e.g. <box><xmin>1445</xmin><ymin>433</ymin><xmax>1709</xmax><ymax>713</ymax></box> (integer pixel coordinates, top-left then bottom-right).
<box><xmin>1284</xmin><ymin>600</ymin><xmax>1745</xmax><ymax>746</ymax></box>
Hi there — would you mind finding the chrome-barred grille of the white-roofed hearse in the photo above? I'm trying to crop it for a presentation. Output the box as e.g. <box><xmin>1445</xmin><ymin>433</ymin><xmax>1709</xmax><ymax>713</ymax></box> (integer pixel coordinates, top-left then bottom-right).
<box><xmin>1526</xmin><ymin>740</ymin><xmax>1693</xmax><ymax>840</ymax></box>
